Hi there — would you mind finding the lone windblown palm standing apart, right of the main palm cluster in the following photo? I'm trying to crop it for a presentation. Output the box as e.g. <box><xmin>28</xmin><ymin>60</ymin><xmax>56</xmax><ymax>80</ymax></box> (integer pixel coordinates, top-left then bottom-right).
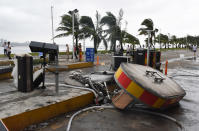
<box><xmin>138</xmin><ymin>18</ymin><xmax>158</xmax><ymax>47</ymax></box>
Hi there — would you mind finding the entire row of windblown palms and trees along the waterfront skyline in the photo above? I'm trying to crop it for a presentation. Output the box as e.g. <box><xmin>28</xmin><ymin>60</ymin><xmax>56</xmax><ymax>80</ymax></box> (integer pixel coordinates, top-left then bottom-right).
<box><xmin>55</xmin><ymin>9</ymin><xmax>199</xmax><ymax>52</ymax></box>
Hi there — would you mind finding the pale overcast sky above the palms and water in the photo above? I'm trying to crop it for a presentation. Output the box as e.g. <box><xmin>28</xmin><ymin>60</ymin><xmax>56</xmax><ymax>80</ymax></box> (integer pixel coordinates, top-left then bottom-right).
<box><xmin>0</xmin><ymin>0</ymin><xmax>199</xmax><ymax>44</ymax></box>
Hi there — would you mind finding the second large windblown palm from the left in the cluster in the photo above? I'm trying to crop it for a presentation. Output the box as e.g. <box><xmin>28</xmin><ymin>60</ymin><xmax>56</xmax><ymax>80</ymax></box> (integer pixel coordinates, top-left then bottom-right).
<box><xmin>80</xmin><ymin>11</ymin><xmax>108</xmax><ymax>53</ymax></box>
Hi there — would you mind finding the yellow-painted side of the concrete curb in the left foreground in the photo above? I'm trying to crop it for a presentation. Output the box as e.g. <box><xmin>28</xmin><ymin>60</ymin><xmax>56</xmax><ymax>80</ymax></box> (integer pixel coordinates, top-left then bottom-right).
<box><xmin>1</xmin><ymin>93</ymin><xmax>94</xmax><ymax>131</ymax></box>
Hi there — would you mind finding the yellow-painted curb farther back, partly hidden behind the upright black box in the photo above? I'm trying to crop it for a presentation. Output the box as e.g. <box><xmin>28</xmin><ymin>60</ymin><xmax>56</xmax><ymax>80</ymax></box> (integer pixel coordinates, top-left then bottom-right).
<box><xmin>0</xmin><ymin>62</ymin><xmax>94</xmax><ymax>80</ymax></box>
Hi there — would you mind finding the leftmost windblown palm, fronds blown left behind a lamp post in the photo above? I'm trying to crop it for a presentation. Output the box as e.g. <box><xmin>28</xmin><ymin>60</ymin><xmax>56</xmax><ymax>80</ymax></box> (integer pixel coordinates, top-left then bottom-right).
<box><xmin>55</xmin><ymin>14</ymin><xmax>80</xmax><ymax>52</ymax></box>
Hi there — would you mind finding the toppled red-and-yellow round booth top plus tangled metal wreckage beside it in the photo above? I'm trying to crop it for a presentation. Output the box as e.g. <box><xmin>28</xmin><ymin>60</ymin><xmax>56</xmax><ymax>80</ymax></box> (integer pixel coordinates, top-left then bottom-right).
<box><xmin>70</xmin><ymin>63</ymin><xmax>186</xmax><ymax>109</ymax></box>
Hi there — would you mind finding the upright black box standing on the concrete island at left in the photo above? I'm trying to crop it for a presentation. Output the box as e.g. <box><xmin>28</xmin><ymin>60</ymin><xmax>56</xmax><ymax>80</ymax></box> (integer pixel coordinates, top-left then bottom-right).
<box><xmin>16</xmin><ymin>54</ymin><xmax>33</xmax><ymax>92</ymax></box>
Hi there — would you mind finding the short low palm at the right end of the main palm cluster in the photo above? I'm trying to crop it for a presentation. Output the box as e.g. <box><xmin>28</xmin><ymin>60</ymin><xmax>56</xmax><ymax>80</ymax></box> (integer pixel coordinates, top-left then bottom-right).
<box><xmin>122</xmin><ymin>31</ymin><xmax>140</xmax><ymax>50</ymax></box>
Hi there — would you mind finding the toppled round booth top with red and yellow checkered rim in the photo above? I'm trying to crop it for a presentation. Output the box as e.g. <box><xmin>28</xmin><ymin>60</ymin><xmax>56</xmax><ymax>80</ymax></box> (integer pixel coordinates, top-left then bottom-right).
<box><xmin>113</xmin><ymin>63</ymin><xmax>186</xmax><ymax>109</ymax></box>
